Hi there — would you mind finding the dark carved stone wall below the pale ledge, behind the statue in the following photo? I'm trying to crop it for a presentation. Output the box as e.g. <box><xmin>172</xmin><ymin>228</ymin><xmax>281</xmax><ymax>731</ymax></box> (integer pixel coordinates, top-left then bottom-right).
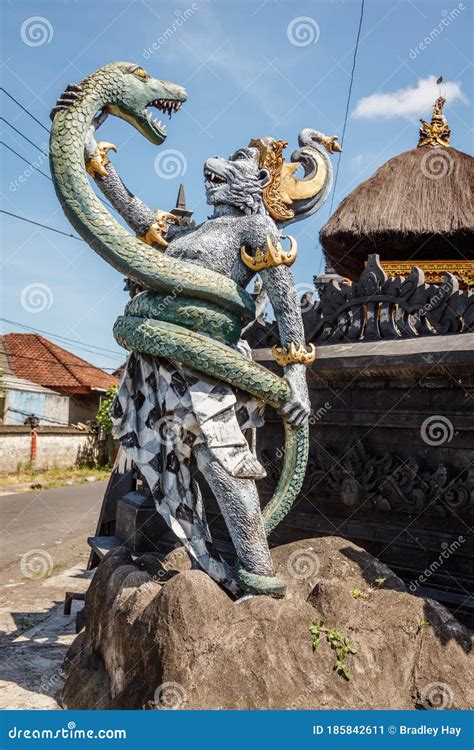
<box><xmin>206</xmin><ymin>333</ymin><xmax>474</xmax><ymax>622</ymax></box>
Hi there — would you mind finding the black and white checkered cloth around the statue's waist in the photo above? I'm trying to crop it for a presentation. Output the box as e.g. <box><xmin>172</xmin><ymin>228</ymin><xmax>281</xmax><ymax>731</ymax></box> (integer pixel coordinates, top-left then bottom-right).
<box><xmin>111</xmin><ymin>352</ymin><xmax>265</xmax><ymax>594</ymax></box>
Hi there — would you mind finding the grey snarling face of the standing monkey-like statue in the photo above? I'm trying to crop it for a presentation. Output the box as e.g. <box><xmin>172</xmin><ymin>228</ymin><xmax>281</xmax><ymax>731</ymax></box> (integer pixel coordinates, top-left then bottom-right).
<box><xmin>204</xmin><ymin>148</ymin><xmax>270</xmax><ymax>213</ymax></box>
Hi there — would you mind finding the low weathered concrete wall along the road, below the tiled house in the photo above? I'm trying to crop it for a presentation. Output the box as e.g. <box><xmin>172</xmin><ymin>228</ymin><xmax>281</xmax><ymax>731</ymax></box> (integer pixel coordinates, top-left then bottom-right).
<box><xmin>0</xmin><ymin>425</ymin><xmax>94</xmax><ymax>474</ymax></box>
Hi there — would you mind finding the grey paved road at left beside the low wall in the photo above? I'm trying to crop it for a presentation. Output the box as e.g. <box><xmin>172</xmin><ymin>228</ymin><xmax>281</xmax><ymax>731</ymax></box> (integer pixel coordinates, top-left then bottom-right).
<box><xmin>0</xmin><ymin>481</ymin><xmax>107</xmax><ymax>567</ymax></box>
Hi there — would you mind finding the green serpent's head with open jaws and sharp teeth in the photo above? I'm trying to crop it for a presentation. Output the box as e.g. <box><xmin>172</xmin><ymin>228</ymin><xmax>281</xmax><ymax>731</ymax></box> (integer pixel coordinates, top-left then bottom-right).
<box><xmin>81</xmin><ymin>62</ymin><xmax>187</xmax><ymax>145</ymax></box>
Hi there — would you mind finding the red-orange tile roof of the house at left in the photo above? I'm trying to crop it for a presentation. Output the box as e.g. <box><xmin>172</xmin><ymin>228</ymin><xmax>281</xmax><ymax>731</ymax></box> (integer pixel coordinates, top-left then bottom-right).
<box><xmin>0</xmin><ymin>333</ymin><xmax>118</xmax><ymax>393</ymax></box>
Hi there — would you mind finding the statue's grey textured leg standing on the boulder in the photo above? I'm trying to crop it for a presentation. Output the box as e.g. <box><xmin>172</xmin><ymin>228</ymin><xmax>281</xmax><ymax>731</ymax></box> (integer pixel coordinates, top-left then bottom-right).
<box><xmin>195</xmin><ymin>444</ymin><xmax>285</xmax><ymax>596</ymax></box>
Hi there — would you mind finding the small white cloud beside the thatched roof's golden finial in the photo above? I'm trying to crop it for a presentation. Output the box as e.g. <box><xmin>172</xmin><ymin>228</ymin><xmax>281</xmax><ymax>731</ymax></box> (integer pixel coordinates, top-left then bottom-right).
<box><xmin>353</xmin><ymin>76</ymin><xmax>466</xmax><ymax>119</ymax></box>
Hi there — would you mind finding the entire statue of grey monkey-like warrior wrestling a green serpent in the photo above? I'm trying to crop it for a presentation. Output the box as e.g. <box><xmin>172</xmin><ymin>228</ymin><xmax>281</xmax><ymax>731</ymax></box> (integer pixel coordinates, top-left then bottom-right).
<box><xmin>50</xmin><ymin>63</ymin><xmax>340</xmax><ymax>597</ymax></box>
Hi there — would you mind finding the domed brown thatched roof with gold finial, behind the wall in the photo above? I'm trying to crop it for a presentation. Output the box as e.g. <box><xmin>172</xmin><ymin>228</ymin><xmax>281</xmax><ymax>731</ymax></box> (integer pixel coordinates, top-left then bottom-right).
<box><xmin>320</xmin><ymin>146</ymin><xmax>474</xmax><ymax>279</ymax></box>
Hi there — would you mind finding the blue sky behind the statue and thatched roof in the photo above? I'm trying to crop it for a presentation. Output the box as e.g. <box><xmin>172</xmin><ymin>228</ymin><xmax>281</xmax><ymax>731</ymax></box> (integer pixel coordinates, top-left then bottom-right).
<box><xmin>0</xmin><ymin>0</ymin><xmax>473</xmax><ymax>371</ymax></box>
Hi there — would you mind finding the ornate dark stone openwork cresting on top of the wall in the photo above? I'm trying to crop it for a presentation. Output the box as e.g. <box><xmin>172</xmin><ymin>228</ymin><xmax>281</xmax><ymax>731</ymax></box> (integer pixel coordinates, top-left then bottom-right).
<box><xmin>247</xmin><ymin>255</ymin><xmax>474</xmax><ymax>348</ymax></box>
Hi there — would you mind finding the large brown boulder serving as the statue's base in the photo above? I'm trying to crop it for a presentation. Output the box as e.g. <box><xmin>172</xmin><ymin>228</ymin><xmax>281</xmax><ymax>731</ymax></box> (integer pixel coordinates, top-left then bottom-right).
<box><xmin>60</xmin><ymin>537</ymin><xmax>474</xmax><ymax>709</ymax></box>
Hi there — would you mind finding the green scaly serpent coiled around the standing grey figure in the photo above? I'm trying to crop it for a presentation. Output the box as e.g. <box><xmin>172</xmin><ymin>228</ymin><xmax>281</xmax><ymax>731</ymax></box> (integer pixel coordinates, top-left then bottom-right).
<box><xmin>50</xmin><ymin>63</ymin><xmax>308</xmax><ymax>535</ymax></box>
